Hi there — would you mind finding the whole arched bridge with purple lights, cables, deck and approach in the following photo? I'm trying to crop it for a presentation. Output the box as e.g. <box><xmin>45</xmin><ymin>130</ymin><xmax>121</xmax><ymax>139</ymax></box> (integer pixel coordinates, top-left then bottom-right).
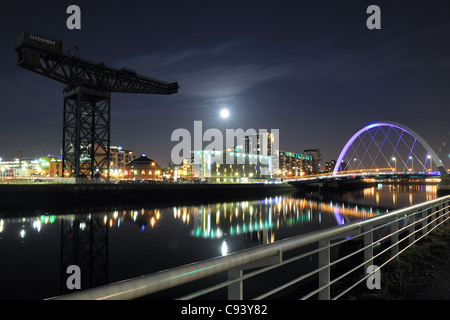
<box><xmin>289</xmin><ymin>121</ymin><xmax>450</xmax><ymax>189</ymax></box>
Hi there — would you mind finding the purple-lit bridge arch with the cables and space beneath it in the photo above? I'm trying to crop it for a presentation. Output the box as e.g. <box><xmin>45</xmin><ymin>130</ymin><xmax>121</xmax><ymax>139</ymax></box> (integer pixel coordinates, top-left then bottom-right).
<box><xmin>333</xmin><ymin>121</ymin><xmax>448</xmax><ymax>177</ymax></box>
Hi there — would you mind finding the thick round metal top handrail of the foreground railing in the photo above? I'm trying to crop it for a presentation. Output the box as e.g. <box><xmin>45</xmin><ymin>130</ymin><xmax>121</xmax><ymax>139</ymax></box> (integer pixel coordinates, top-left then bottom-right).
<box><xmin>51</xmin><ymin>195</ymin><xmax>450</xmax><ymax>300</ymax></box>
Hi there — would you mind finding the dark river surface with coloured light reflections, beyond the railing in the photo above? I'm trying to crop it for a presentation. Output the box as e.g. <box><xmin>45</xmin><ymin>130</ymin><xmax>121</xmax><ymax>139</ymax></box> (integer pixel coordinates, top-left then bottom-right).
<box><xmin>0</xmin><ymin>185</ymin><xmax>436</xmax><ymax>299</ymax></box>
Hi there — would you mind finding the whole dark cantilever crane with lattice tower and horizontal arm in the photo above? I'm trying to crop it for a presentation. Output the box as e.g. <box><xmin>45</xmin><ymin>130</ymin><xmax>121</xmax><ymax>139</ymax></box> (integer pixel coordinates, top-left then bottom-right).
<box><xmin>15</xmin><ymin>31</ymin><xmax>179</xmax><ymax>178</ymax></box>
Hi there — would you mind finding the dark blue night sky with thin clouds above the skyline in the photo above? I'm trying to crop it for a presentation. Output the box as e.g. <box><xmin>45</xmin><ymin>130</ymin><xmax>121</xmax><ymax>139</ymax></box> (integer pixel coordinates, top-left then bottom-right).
<box><xmin>0</xmin><ymin>0</ymin><xmax>450</xmax><ymax>168</ymax></box>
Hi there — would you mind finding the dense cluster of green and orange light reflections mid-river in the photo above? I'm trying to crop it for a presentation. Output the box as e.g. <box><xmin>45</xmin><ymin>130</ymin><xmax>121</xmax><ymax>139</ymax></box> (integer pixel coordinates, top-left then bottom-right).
<box><xmin>181</xmin><ymin>196</ymin><xmax>380</xmax><ymax>243</ymax></box>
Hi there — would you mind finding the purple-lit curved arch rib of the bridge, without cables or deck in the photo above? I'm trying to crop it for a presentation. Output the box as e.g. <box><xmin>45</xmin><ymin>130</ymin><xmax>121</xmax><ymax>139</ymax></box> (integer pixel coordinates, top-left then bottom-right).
<box><xmin>333</xmin><ymin>121</ymin><xmax>447</xmax><ymax>176</ymax></box>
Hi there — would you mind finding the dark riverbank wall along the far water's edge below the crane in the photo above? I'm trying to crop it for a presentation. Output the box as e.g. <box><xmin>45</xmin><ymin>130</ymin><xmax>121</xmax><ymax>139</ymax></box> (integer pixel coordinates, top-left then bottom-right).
<box><xmin>0</xmin><ymin>183</ymin><xmax>297</xmax><ymax>208</ymax></box>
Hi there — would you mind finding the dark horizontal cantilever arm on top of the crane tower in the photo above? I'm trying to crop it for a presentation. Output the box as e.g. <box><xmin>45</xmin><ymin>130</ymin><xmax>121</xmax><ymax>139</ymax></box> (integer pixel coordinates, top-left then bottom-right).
<box><xmin>16</xmin><ymin>33</ymin><xmax>179</xmax><ymax>94</ymax></box>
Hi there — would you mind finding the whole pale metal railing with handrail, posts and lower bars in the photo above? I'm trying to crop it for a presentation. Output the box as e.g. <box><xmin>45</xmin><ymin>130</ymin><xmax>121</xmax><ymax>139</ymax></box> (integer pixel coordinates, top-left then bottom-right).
<box><xmin>52</xmin><ymin>196</ymin><xmax>450</xmax><ymax>300</ymax></box>
